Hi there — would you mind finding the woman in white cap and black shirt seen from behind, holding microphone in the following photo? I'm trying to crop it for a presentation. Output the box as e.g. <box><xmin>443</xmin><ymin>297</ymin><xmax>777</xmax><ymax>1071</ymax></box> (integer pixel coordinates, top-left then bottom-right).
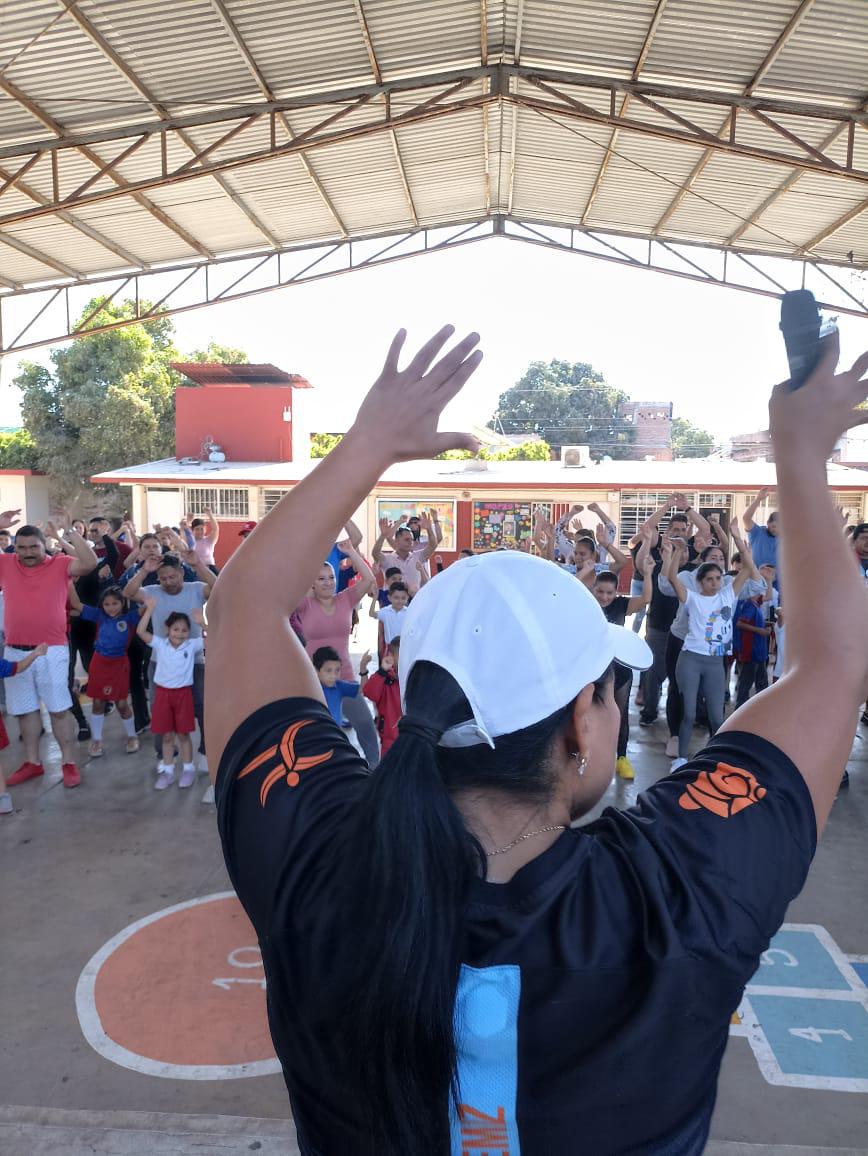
<box><xmin>207</xmin><ymin>328</ymin><xmax>868</xmax><ymax>1156</ymax></box>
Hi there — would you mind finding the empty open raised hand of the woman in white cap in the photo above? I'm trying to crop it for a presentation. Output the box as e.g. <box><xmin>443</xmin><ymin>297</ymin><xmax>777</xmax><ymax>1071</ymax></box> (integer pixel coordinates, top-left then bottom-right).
<box><xmin>351</xmin><ymin>325</ymin><xmax>482</xmax><ymax>461</ymax></box>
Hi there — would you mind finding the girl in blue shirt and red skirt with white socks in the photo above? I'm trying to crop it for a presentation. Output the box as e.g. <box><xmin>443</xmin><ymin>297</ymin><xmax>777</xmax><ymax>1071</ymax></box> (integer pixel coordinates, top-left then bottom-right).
<box><xmin>81</xmin><ymin>586</ymin><xmax>139</xmax><ymax>758</ymax></box>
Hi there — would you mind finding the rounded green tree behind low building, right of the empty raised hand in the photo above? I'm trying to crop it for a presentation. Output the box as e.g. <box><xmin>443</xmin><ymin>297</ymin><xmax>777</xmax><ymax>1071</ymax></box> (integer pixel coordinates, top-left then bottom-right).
<box><xmin>488</xmin><ymin>361</ymin><xmax>636</xmax><ymax>458</ymax></box>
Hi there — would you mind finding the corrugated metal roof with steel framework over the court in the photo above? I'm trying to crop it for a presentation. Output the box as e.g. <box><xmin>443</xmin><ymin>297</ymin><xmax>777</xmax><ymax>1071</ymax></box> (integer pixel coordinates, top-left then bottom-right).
<box><xmin>0</xmin><ymin>0</ymin><xmax>868</xmax><ymax>292</ymax></box>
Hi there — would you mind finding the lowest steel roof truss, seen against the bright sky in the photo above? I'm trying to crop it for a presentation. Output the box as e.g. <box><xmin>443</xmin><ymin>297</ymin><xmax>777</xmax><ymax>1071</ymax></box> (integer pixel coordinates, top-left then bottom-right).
<box><xmin>0</xmin><ymin>216</ymin><xmax>868</xmax><ymax>356</ymax></box>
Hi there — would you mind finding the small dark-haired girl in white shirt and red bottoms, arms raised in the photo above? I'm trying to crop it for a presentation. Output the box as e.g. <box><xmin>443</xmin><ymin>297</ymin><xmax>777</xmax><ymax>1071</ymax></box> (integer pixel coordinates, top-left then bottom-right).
<box><xmin>136</xmin><ymin>594</ymin><xmax>205</xmax><ymax>791</ymax></box>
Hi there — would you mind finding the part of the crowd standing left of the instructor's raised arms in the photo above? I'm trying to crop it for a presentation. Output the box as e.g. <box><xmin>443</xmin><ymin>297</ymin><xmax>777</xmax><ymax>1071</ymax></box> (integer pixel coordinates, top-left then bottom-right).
<box><xmin>0</xmin><ymin>510</ymin><xmax>224</xmax><ymax>815</ymax></box>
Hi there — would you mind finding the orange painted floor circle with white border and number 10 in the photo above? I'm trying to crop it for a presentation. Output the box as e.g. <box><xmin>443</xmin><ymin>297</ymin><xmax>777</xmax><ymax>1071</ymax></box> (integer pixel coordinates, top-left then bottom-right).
<box><xmin>76</xmin><ymin>894</ymin><xmax>279</xmax><ymax>1079</ymax></box>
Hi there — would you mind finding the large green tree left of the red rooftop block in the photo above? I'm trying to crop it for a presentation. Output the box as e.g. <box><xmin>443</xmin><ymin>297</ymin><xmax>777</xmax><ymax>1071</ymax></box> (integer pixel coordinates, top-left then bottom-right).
<box><xmin>13</xmin><ymin>298</ymin><xmax>180</xmax><ymax>507</ymax></box>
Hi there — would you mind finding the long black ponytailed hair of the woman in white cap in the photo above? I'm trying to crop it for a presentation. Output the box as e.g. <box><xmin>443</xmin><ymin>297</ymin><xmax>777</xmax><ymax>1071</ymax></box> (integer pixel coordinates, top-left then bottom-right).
<box><xmin>337</xmin><ymin>662</ymin><xmax>580</xmax><ymax>1156</ymax></box>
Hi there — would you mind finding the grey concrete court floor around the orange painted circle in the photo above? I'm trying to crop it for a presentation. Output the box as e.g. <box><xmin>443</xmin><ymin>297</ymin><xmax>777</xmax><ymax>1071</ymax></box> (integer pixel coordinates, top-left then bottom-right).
<box><xmin>0</xmin><ymin>675</ymin><xmax>868</xmax><ymax>1156</ymax></box>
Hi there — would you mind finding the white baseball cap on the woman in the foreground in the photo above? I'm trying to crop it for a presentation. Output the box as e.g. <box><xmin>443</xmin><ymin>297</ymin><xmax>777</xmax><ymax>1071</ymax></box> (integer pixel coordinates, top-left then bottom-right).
<box><xmin>399</xmin><ymin>550</ymin><xmax>652</xmax><ymax>747</ymax></box>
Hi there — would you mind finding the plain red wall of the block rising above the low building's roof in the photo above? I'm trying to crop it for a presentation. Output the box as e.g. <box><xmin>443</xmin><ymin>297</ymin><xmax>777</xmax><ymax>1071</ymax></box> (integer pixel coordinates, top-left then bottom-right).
<box><xmin>175</xmin><ymin>385</ymin><xmax>292</xmax><ymax>461</ymax></box>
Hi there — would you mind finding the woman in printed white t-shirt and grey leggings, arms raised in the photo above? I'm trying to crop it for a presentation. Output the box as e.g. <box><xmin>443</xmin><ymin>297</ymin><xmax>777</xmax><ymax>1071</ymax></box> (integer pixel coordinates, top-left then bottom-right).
<box><xmin>661</xmin><ymin>540</ymin><xmax>758</xmax><ymax>771</ymax></box>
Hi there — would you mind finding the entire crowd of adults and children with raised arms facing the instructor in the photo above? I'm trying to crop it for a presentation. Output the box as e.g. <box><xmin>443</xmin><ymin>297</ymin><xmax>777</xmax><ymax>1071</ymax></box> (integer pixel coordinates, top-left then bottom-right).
<box><xmin>0</xmin><ymin>490</ymin><xmax>868</xmax><ymax>814</ymax></box>
